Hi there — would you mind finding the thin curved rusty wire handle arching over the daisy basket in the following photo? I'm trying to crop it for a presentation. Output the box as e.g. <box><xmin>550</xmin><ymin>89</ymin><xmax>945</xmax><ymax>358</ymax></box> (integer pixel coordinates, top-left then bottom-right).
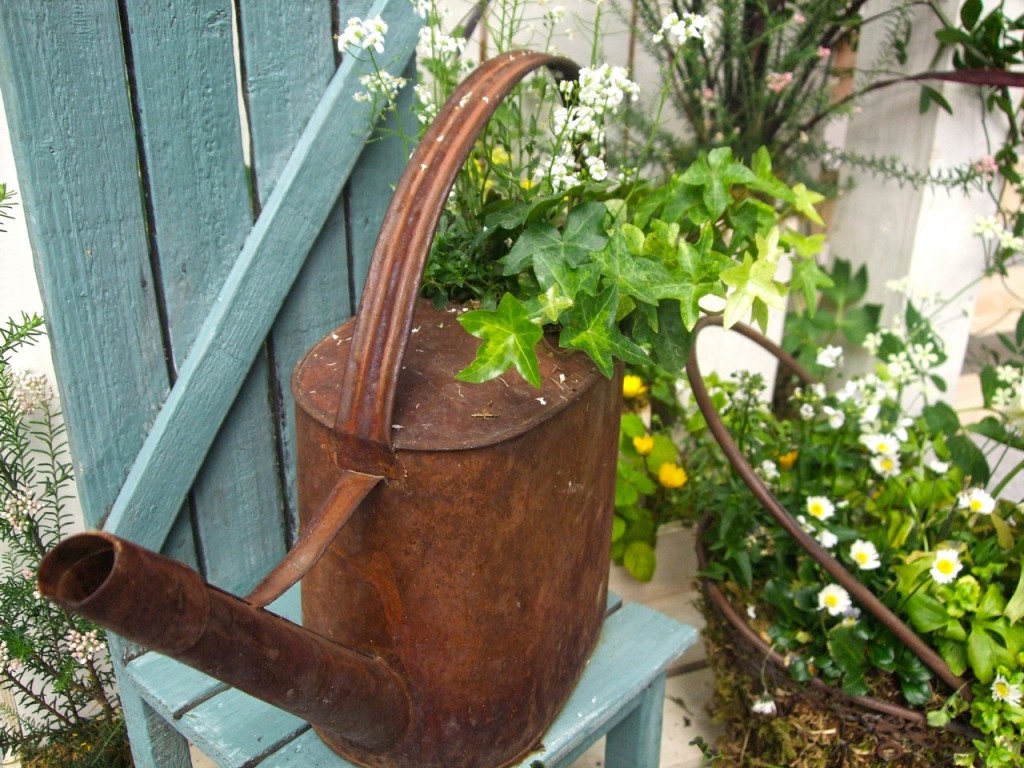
<box><xmin>686</xmin><ymin>316</ymin><xmax>971</xmax><ymax>697</ymax></box>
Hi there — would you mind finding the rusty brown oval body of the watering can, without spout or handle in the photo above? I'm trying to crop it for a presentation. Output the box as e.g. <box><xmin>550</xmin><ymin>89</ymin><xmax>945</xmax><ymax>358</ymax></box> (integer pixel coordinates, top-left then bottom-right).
<box><xmin>293</xmin><ymin>304</ymin><xmax>621</xmax><ymax>768</ymax></box>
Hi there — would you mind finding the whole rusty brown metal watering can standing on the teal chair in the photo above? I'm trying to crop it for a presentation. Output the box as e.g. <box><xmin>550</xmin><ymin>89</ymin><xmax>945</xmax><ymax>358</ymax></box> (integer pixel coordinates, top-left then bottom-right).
<box><xmin>39</xmin><ymin>52</ymin><xmax>621</xmax><ymax>768</ymax></box>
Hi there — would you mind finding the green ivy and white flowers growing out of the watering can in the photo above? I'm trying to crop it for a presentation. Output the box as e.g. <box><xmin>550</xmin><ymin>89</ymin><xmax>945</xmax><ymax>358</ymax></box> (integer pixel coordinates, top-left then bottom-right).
<box><xmin>340</xmin><ymin>0</ymin><xmax>823</xmax><ymax>391</ymax></box>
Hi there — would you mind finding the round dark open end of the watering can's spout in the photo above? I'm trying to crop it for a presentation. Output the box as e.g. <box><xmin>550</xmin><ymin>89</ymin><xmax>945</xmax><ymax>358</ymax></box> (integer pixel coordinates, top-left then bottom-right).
<box><xmin>39</xmin><ymin>534</ymin><xmax>117</xmax><ymax>606</ymax></box>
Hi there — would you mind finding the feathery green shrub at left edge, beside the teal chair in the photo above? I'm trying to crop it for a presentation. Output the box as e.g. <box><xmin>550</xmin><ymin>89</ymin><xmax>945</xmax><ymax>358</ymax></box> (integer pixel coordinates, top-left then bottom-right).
<box><xmin>0</xmin><ymin>315</ymin><xmax>130</xmax><ymax>768</ymax></box>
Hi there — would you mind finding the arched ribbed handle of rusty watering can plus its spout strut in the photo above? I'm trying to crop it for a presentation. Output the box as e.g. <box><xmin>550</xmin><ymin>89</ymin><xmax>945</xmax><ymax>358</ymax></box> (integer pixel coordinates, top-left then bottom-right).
<box><xmin>239</xmin><ymin>51</ymin><xmax>579</xmax><ymax>606</ymax></box>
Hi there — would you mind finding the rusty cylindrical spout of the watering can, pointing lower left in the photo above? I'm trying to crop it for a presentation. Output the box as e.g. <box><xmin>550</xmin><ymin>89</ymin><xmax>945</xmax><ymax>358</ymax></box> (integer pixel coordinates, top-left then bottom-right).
<box><xmin>39</xmin><ymin>531</ymin><xmax>410</xmax><ymax>750</ymax></box>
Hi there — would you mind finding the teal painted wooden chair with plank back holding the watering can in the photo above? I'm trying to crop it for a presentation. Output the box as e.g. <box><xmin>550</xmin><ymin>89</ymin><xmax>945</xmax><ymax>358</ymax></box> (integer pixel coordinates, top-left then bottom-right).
<box><xmin>0</xmin><ymin>0</ymin><xmax>694</xmax><ymax>768</ymax></box>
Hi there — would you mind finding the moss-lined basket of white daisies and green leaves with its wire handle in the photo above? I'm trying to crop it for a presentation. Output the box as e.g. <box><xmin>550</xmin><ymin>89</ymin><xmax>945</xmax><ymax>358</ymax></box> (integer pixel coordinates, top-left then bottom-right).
<box><xmin>685</xmin><ymin>286</ymin><xmax>1024</xmax><ymax>766</ymax></box>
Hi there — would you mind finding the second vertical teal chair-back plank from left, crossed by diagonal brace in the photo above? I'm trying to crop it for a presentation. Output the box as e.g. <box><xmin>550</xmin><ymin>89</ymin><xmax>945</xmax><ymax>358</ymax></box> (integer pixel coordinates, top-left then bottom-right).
<box><xmin>125</xmin><ymin>0</ymin><xmax>286</xmax><ymax>591</ymax></box>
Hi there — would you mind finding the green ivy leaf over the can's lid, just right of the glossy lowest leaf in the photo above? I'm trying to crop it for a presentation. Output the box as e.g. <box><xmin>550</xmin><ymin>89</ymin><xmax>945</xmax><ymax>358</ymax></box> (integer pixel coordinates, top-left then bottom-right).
<box><xmin>561</xmin><ymin>286</ymin><xmax>648</xmax><ymax>378</ymax></box>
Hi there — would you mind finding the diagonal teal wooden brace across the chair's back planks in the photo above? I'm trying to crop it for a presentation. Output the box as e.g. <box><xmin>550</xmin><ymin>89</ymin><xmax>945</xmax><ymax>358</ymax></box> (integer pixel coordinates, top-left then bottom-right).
<box><xmin>106</xmin><ymin>0</ymin><xmax>419</xmax><ymax>548</ymax></box>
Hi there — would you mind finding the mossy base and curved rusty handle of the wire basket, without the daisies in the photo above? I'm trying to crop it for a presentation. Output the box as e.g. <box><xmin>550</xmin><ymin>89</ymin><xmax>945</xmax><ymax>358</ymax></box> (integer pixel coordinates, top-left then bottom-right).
<box><xmin>687</xmin><ymin>317</ymin><xmax>977</xmax><ymax>768</ymax></box>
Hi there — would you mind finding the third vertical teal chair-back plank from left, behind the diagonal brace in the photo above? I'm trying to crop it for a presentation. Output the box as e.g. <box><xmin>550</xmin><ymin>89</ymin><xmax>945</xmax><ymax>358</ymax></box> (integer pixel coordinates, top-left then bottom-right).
<box><xmin>239</xmin><ymin>0</ymin><xmax>351</xmax><ymax>532</ymax></box>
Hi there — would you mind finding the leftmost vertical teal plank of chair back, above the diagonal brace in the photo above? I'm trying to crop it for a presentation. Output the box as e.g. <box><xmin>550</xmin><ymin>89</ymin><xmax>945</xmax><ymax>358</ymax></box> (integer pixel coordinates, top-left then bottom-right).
<box><xmin>0</xmin><ymin>0</ymin><xmax>168</xmax><ymax>525</ymax></box>
